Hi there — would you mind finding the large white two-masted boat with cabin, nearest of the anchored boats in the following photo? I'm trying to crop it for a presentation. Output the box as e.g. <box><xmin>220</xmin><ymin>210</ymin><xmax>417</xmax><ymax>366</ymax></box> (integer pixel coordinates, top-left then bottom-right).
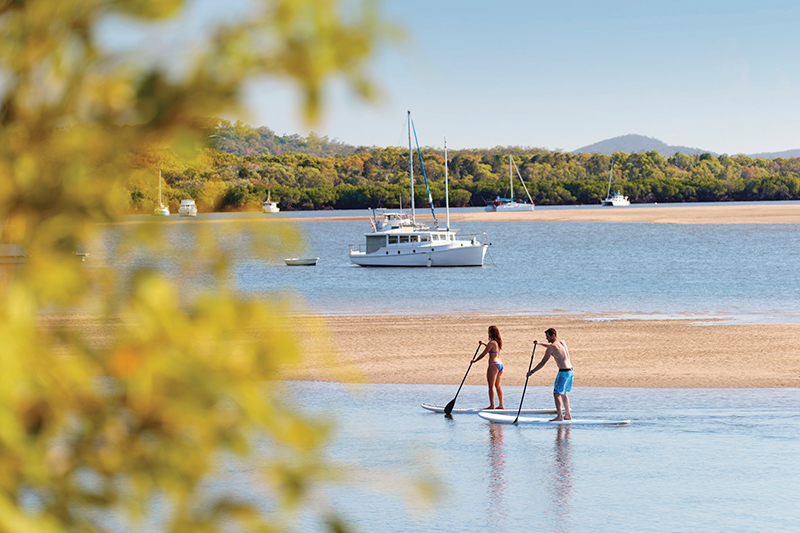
<box><xmin>350</xmin><ymin>111</ymin><xmax>489</xmax><ymax>267</ymax></box>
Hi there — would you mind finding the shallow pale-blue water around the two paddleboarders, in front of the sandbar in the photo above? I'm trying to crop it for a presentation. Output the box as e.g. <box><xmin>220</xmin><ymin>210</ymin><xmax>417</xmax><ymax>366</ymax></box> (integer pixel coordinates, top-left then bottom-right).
<box><xmin>282</xmin><ymin>382</ymin><xmax>800</xmax><ymax>533</ymax></box>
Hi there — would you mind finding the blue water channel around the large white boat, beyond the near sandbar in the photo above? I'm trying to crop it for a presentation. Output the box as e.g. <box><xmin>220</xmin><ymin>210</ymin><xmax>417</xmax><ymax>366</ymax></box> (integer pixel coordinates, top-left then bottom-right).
<box><xmin>103</xmin><ymin>202</ymin><xmax>800</xmax><ymax>323</ymax></box>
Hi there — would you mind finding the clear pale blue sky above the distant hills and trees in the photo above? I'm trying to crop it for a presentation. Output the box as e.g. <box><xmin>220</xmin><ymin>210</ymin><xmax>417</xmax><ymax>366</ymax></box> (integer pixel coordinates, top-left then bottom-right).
<box><xmin>103</xmin><ymin>0</ymin><xmax>800</xmax><ymax>154</ymax></box>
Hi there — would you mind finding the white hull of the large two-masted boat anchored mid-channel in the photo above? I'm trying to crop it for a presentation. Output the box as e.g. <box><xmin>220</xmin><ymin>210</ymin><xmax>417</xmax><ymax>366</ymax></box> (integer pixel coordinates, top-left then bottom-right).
<box><xmin>350</xmin><ymin>241</ymin><xmax>487</xmax><ymax>267</ymax></box>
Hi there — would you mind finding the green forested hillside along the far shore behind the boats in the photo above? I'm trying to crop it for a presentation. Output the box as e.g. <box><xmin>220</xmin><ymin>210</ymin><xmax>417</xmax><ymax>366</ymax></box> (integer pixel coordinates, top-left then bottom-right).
<box><xmin>127</xmin><ymin>119</ymin><xmax>800</xmax><ymax>213</ymax></box>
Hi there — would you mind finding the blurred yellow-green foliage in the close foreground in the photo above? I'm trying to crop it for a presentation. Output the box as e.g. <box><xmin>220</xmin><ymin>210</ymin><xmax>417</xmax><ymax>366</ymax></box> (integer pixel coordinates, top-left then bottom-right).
<box><xmin>0</xmin><ymin>0</ymin><xmax>400</xmax><ymax>533</ymax></box>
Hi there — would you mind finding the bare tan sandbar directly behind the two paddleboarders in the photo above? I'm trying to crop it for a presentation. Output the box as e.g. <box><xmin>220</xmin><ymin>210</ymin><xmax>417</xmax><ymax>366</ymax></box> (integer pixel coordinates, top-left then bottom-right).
<box><xmin>286</xmin><ymin>314</ymin><xmax>800</xmax><ymax>389</ymax></box>
